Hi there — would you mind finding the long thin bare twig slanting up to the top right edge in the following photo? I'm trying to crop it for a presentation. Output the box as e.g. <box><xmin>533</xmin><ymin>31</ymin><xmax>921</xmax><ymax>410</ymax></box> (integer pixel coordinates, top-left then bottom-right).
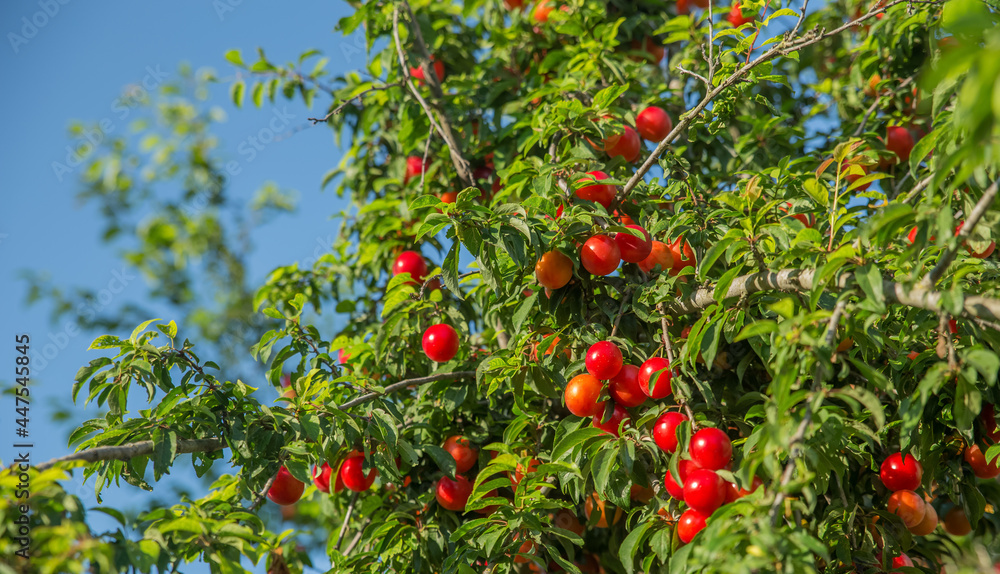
<box><xmin>622</xmin><ymin>0</ymin><xmax>907</xmax><ymax>194</ymax></box>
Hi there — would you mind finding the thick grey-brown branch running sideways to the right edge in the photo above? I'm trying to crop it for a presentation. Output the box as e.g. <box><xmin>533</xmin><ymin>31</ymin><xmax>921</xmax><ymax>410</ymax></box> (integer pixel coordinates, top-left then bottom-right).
<box><xmin>666</xmin><ymin>269</ymin><xmax>1000</xmax><ymax>321</ymax></box>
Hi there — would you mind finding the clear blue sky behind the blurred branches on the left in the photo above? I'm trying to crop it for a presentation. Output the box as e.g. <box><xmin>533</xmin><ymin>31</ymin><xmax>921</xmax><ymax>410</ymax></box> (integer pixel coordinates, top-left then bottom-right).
<box><xmin>0</xmin><ymin>0</ymin><xmax>364</xmax><ymax>572</ymax></box>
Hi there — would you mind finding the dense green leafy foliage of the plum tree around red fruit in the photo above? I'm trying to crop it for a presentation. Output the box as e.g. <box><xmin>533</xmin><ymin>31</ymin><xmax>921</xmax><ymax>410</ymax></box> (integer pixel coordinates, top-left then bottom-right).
<box><xmin>9</xmin><ymin>0</ymin><xmax>1000</xmax><ymax>574</ymax></box>
